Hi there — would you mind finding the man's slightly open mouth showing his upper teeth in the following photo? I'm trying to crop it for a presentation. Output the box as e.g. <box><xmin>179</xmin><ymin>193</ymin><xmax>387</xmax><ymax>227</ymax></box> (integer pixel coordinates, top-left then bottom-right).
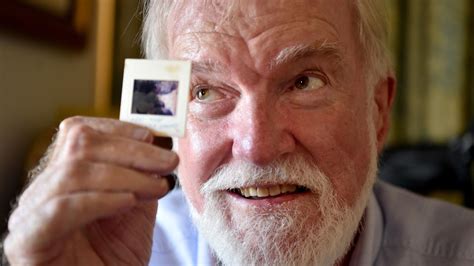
<box><xmin>229</xmin><ymin>184</ymin><xmax>309</xmax><ymax>199</ymax></box>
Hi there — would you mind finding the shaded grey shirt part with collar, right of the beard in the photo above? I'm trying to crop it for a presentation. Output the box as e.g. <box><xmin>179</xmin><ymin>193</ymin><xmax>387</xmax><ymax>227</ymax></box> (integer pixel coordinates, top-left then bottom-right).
<box><xmin>351</xmin><ymin>182</ymin><xmax>474</xmax><ymax>266</ymax></box>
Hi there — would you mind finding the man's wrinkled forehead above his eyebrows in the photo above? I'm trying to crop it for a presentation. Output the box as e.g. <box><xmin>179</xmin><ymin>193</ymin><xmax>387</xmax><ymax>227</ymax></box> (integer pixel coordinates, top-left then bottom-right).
<box><xmin>168</xmin><ymin>0</ymin><xmax>354</xmax><ymax>49</ymax></box>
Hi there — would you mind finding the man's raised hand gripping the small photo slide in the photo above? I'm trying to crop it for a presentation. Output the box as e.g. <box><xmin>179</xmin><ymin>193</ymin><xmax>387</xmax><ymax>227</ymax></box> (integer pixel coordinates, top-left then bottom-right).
<box><xmin>4</xmin><ymin>117</ymin><xmax>178</xmax><ymax>265</ymax></box>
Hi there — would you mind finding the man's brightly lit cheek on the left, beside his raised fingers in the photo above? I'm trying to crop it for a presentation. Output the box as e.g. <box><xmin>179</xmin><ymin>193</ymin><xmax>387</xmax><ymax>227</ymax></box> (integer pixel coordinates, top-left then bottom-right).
<box><xmin>178</xmin><ymin>118</ymin><xmax>228</xmax><ymax>212</ymax></box>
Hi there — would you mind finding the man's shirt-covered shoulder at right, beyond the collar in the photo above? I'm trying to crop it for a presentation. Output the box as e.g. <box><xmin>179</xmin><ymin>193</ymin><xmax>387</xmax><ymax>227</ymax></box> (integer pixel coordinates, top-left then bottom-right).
<box><xmin>374</xmin><ymin>182</ymin><xmax>474</xmax><ymax>265</ymax></box>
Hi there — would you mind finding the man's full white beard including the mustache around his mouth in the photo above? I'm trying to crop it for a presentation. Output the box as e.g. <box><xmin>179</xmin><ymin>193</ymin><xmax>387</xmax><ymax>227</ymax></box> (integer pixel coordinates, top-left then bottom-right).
<box><xmin>188</xmin><ymin>147</ymin><xmax>377</xmax><ymax>265</ymax></box>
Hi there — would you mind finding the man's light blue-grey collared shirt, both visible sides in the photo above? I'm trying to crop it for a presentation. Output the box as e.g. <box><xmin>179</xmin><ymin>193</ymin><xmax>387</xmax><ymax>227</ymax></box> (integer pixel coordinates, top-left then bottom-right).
<box><xmin>150</xmin><ymin>182</ymin><xmax>474</xmax><ymax>266</ymax></box>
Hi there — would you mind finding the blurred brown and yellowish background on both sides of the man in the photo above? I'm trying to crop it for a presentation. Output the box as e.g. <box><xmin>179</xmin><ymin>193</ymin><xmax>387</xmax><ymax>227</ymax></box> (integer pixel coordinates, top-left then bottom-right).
<box><xmin>0</xmin><ymin>0</ymin><xmax>474</xmax><ymax>236</ymax></box>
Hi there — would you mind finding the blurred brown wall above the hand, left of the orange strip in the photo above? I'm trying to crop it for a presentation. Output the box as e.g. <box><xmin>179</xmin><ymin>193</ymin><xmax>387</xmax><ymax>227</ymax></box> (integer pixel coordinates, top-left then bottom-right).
<box><xmin>0</xmin><ymin>2</ymin><xmax>96</xmax><ymax>235</ymax></box>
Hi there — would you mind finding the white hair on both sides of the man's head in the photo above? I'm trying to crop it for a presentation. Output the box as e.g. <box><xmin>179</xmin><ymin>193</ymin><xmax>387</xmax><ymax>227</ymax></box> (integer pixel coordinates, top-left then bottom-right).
<box><xmin>142</xmin><ymin>0</ymin><xmax>392</xmax><ymax>87</ymax></box>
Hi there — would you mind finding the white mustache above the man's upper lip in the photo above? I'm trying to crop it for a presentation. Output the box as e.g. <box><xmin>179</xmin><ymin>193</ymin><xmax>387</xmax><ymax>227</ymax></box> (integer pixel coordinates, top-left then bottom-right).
<box><xmin>201</xmin><ymin>155</ymin><xmax>328</xmax><ymax>195</ymax></box>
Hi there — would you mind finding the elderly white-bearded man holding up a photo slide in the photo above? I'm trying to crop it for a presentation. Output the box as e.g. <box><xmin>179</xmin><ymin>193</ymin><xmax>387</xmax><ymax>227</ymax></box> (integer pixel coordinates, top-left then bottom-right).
<box><xmin>5</xmin><ymin>0</ymin><xmax>474</xmax><ymax>265</ymax></box>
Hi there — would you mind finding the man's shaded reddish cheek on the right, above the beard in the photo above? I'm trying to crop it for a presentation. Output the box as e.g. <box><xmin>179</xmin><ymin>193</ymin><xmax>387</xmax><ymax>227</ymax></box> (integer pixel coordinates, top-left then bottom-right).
<box><xmin>299</xmin><ymin>102</ymin><xmax>373</xmax><ymax>205</ymax></box>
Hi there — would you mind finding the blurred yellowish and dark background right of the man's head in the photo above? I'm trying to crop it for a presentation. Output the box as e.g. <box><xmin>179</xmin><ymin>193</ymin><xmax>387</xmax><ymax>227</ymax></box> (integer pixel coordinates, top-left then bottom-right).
<box><xmin>379</xmin><ymin>0</ymin><xmax>474</xmax><ymax>207</ymax></box>
